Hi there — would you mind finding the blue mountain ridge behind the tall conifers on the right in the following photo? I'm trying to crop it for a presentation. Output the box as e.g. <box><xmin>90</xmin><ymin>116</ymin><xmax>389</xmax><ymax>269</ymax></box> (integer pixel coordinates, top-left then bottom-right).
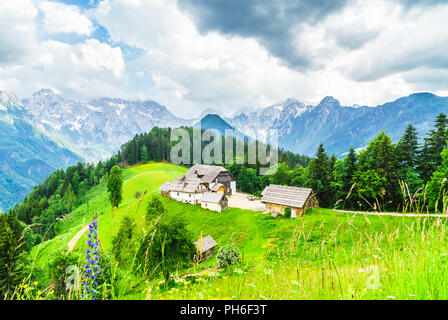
<box><xmin>228</xmin><ymin>93</ymin><xmax>448</xmax><ymax>156</ymax></box>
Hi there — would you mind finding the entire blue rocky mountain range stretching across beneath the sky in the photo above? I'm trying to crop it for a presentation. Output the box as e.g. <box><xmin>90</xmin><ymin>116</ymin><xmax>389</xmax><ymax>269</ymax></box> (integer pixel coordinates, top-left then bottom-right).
<box><xmin>0</xmin><ymin>89</ymin><xmax>448</xmax><ymax>211</ymax></box>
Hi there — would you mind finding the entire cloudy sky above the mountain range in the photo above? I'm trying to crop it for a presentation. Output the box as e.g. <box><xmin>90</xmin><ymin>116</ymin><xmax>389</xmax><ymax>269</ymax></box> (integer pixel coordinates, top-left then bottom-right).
<box><xmin>0</xmin><ymin>0</ymin><xmax>448</xmax><ymax>118</ymax></box>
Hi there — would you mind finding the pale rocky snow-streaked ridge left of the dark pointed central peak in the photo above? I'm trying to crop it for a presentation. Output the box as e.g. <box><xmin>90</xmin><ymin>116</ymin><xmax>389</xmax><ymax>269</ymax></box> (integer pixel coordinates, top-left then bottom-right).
<box><xmin>22</xmin><ymin>89</ymin><xmax>190</xmax><ymax>161</ymax></box>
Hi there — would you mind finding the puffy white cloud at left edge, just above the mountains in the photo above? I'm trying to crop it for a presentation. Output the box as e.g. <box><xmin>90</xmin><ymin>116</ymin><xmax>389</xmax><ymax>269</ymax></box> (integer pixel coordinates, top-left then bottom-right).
<box><xmin>0</xmin><ymin>39</ymin><xmax>127</xmax><ymax>100</ymax></box>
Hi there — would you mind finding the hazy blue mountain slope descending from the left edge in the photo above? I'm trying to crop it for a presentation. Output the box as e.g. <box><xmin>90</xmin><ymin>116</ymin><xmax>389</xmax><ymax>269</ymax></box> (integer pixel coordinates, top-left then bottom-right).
<box><xmin>0</xmin><ymin>91</ymin><xmax>83</xmax><ymax>212</ymax></box>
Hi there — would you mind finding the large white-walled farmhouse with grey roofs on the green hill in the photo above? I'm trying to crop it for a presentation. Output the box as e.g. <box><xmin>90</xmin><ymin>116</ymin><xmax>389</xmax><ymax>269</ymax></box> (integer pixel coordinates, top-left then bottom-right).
<box><xmin>159</xmin><ymin>164</ymin><xmax>236</xmax><ymax>212</ymax></box>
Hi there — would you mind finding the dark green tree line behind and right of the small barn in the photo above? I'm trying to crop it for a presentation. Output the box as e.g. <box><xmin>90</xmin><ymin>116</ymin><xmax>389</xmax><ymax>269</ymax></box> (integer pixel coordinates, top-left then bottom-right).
<box><xmin>256</xmin><ymin>113</ymin><xmax>448</xmax><ymax>211</ymax></box>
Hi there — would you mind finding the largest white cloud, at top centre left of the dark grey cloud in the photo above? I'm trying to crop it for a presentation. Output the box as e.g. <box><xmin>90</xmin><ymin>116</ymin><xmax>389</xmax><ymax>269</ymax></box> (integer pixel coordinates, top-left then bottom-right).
<box><xmin>93</xmin><ymin>0</ymin><xmax>320</xmax><ymax>116</ymax></box>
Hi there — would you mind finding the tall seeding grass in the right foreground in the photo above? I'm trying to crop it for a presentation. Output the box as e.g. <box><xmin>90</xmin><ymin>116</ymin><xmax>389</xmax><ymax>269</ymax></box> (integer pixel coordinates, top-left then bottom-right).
<box><xmin>149</xmin><ymin>212</ymin><xmax>448</xmax><ymax>299</ymax></box>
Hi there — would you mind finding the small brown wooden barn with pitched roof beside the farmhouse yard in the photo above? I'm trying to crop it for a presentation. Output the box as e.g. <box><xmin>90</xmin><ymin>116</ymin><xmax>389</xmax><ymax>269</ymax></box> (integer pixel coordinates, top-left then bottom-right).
<box><xmin>261</xmin><ymin>184</ymin><xmax>319</xmax><ymax>218</ymax></box>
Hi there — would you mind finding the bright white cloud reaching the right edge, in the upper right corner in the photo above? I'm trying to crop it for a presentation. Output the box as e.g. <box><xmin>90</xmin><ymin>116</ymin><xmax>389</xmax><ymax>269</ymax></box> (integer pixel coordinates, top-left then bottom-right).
<box><xmin>346</xmin><ymin>5</ymin><xmax>448</xmax><ymax>81</ymax></box>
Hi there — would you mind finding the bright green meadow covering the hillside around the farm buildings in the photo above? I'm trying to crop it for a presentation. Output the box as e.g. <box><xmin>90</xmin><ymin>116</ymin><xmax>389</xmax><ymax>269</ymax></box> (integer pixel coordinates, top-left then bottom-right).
<box><xmin>30</xmin><ymin>163</ymin><xmax>448</xmax><ymax>299</ymax></box>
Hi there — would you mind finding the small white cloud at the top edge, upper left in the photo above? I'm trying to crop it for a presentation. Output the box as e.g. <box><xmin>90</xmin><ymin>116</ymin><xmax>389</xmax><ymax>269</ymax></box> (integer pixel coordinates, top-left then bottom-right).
<box><xmin>39</xmin><ymin>1</ymin><xmax>93</xmax><ymax>36</ymax></box>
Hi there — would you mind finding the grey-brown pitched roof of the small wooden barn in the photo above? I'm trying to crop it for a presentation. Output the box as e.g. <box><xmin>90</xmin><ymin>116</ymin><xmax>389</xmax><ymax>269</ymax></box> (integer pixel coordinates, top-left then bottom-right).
<box><xmin>261</xmin><ymin>184</ymin><xmax>313</xmax><ymax>208</ymax></box>
